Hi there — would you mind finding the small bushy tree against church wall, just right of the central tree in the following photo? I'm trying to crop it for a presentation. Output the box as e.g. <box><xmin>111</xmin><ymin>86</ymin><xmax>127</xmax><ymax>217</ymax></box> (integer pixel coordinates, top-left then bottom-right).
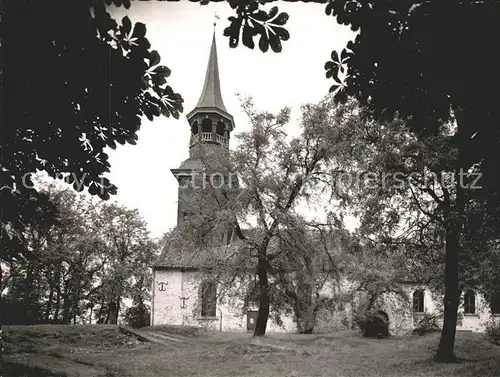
<box><xmin>271</xmin><ymin>220</ymin><xmax>350</xmax><ymax>334</ymax></box>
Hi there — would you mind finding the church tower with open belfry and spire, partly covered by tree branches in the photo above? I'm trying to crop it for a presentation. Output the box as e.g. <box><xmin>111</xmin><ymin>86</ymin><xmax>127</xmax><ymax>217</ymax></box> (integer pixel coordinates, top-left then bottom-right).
<box><xmin>170</xmin><ymin>30</ymin><xmax>234</xmax><ymax>224</ymax></box>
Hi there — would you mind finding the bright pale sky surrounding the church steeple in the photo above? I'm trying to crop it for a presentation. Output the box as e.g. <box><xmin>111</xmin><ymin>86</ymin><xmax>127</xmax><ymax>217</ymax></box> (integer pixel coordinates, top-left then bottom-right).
<box><xmin>100</xmin><ymin>0</ymin><xmax>354</xmax><ymax>236</ymax></box>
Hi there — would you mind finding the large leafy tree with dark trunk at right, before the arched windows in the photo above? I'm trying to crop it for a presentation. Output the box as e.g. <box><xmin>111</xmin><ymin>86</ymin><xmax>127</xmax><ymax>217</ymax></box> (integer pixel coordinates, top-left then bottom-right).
<box><xmin>322</xmin><ymin>95</ymin><xmax>497</xmax><ymax>357</ymax></box>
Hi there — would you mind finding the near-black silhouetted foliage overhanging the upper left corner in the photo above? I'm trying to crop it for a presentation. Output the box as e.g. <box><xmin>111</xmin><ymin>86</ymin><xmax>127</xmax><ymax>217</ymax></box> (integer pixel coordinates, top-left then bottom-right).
<box><xmin>0</xmin><ymin>0</ymin><xmax>182</xmax><ymax>356</ymax></box>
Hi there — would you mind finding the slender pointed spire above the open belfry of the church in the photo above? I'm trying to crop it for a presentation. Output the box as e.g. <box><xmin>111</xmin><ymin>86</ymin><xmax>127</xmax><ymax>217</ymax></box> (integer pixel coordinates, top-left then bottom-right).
<box><xmin>196</xmin><ymin>28</ymin><xmax>227</xmax><ymax>112</ymax></box>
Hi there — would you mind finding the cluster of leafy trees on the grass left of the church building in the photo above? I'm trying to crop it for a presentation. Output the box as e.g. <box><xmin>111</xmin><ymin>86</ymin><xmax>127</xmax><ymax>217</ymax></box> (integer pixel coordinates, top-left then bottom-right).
<box><xmin>1</xmin><ymin>181</ymin><xmax>155</xmax><ymax>324</ymax></box>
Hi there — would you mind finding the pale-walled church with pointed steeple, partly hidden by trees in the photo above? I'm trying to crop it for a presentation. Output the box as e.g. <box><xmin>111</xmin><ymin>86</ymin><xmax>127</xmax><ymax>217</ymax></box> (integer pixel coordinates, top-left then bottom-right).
<box><xmin>151</xmin><ymin>32</ymin><xmax>500</xmax><ymax>335</ymax></box>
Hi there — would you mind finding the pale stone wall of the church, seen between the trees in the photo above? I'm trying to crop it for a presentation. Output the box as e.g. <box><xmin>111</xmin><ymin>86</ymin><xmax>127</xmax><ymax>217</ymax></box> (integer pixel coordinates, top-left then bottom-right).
<box><xmin>152</xmin><ymin>269</ymin><xmax>491</xmax><ymax>336</ymax></box>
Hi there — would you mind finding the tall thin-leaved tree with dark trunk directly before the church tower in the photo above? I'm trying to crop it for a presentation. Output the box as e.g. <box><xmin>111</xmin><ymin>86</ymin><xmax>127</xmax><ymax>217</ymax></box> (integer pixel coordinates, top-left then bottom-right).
<box><xmin>162</xmin><ymin>94</ymin><xmax>354</xmax><ymax>336</ymax></box>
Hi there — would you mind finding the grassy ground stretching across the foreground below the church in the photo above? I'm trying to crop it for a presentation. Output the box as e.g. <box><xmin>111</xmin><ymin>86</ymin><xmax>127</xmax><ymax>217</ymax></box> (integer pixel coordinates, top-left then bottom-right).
<box><xmin>5</xmin><ymin>326</ymin><xmax>500</xmax><ymax>377</ymax></box>
